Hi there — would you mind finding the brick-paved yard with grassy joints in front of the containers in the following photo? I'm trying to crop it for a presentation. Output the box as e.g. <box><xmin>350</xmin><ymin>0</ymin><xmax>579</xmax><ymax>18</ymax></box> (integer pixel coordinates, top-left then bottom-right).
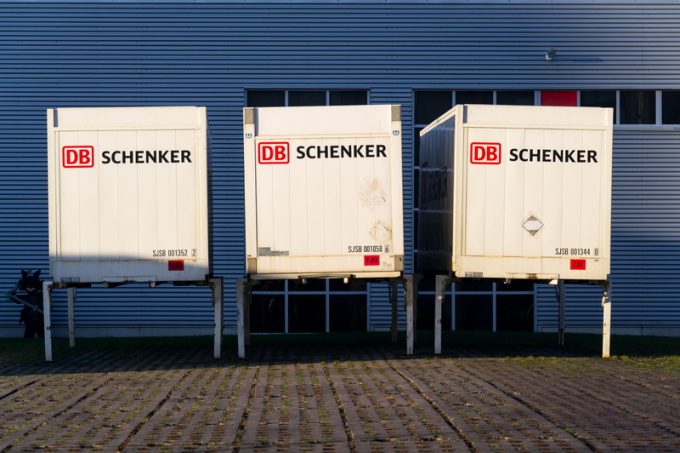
<box><xmin>0</xmin><ymin>340</ymin><xmax>680</xmax><ymax>452</ymax></box>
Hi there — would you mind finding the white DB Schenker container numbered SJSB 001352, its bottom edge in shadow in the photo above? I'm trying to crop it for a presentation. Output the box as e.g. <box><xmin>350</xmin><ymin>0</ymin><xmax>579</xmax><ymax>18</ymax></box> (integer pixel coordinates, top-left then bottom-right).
<box><xmin>47</xmin><ymin>107</ymin><xmax>210</xmax><ymax>284</ymax></box>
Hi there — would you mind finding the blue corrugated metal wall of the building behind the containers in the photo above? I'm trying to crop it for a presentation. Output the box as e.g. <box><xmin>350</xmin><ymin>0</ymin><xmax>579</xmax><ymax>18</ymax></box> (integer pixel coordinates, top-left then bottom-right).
<box><xmin>0</xmin><ymin>1</ymin><xmax>680</xmax><ymax>332</ymax></box>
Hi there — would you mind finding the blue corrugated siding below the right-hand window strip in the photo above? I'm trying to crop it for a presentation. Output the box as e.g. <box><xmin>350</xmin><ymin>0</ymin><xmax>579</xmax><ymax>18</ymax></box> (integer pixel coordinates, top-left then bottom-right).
<box><xmin>538</xmin><ymin>129</ymin><xmax>680</xmax><ymax>331</ymax></box>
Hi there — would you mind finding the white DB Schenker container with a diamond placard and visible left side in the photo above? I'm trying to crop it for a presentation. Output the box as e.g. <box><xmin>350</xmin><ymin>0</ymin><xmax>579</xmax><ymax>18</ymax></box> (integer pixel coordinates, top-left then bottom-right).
<box><xmin>417</xmin><ymin>105</ymin><xmax>613</xmax><ymax>281</ymax></box>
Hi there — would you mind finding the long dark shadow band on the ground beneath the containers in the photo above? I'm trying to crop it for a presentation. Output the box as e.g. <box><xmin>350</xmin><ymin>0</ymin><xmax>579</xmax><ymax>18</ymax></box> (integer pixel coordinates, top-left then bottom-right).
<box><xmin>0</xmin><ymin>331</ymin><xmax>680</xmax><ymax>376</ymax></box>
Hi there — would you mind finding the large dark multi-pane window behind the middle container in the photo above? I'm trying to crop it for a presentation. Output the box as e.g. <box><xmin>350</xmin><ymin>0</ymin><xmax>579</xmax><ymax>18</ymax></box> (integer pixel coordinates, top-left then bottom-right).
<box><xmin>246</xmin><ymin>90</ymin><xmax>368</xmax><ymax>333</ymax></box>
